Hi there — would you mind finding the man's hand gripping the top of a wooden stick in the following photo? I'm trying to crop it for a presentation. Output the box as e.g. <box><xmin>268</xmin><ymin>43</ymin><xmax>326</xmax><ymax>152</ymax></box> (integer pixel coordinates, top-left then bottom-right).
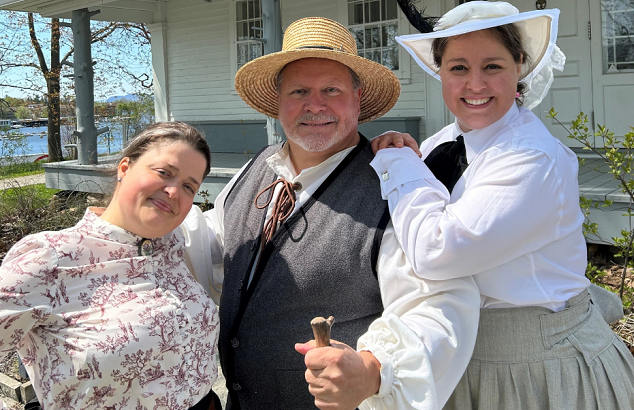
<box><xmin>295</xmin><ymin>340</ymin><xmax>381</xmax><ymax>410</ymax></box>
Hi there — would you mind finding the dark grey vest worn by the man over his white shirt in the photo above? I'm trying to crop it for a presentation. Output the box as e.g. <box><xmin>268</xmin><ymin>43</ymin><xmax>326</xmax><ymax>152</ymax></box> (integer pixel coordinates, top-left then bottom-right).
<box><xmin>219</xmin><ymin>137</ymin><xmax>389</xmax><ymax>410</ymax></box>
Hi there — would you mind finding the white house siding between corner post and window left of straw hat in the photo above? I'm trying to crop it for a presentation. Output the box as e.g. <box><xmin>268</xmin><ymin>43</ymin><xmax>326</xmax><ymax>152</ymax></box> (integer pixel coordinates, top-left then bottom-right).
<box><xmin>167</xmin><ymin>0</ymin><xmax>264</xmax><ymax>123</ymax></box>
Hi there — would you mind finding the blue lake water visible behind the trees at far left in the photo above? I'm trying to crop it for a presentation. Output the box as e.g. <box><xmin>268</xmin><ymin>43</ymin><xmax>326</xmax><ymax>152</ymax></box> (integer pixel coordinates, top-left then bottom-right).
<box><xmin>0</xmin><ymin>124</ymin><xmax>123</xmax><ymax>156</ymax></box>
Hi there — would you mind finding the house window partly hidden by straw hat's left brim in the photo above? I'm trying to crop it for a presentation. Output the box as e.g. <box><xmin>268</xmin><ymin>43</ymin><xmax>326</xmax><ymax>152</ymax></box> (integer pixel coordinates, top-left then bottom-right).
<box><xmin>235</xmin><ymin>0</ymin><xmax>264</xmax><ymax>71</ymax></box>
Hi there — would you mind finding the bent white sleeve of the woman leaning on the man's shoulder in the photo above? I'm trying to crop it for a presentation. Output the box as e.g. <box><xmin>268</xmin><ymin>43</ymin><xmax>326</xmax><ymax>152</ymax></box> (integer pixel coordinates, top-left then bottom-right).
<box><xmin>371</xmin><ymin>148</ymin><xmax>566</xmax><ymax>280</ymax></box>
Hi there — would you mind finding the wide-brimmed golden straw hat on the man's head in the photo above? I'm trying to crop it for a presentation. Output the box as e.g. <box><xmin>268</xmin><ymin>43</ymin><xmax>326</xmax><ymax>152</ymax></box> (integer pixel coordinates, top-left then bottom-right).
<box><xmin>236</xmin><ymin>17</ymin><xmax>401</xmax><ymax>123</ymax></box>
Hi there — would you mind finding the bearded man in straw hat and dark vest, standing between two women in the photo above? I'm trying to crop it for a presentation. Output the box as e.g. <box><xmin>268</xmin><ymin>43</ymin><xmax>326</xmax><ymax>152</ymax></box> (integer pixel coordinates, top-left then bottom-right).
<box><xmin>184</xmin><ymin>18</ymin><xmax>480</xmax><ymax>410</ymax></box>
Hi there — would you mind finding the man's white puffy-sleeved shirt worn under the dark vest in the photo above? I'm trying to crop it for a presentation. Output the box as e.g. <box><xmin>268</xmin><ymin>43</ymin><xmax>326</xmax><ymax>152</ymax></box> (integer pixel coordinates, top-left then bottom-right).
<box><xmin>182</xmin><ymin>145</ymin><xmax>480</xmax><ymax>410</ymax></box>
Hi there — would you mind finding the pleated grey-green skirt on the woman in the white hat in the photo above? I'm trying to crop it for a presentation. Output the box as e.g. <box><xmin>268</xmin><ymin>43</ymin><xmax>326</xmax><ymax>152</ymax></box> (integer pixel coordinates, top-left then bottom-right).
<box><xmin>444</xmin><ymin>291</ymin><xmax>634</xmax><ymax>410</ymax></box>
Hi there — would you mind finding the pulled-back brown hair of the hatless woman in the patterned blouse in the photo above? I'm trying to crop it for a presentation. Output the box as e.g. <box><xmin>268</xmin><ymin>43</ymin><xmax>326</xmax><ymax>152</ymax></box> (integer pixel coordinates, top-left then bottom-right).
<box><xmin>121</xmin><ymin>121</ymin><xmax>211</xmax><ymax>178</ymax></box>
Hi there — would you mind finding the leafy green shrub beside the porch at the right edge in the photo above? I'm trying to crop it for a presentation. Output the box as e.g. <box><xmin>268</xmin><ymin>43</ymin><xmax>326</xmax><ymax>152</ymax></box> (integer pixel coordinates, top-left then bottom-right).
<box><xmin>547</xmin><ymin>108</ymin><xmax>634</xmax><ymax>308</ymax></box>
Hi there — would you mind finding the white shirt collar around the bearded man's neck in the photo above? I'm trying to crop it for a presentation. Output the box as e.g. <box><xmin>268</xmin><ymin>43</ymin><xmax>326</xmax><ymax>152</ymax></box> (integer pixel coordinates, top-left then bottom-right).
<box><xmin>266</xmin><ymin>144</ymin><xmax>354</xmax><ymax>192</ymax></box>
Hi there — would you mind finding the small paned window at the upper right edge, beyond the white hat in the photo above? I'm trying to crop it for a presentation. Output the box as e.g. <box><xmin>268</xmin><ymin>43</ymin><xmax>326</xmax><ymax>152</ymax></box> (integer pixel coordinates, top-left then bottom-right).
<box><xmin>601</xmin><ymin>0</ymin><xmax>634</xmax><ymax>73</ymax></box>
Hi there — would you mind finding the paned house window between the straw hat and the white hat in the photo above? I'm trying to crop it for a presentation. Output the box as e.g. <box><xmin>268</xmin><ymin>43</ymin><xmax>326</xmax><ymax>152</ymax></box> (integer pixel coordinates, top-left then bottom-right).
<box><xmin>348</xmin><ymin>0</ymin><xmax>400</xmax><ymax>70</ymax></box>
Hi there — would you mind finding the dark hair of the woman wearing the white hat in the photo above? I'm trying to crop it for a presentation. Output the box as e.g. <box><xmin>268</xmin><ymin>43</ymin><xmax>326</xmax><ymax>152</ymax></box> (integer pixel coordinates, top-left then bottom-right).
<box><xmin>431</xmin><ymin>24</ymin><xmax>531</xmax><ymax>105</ymax></box>
